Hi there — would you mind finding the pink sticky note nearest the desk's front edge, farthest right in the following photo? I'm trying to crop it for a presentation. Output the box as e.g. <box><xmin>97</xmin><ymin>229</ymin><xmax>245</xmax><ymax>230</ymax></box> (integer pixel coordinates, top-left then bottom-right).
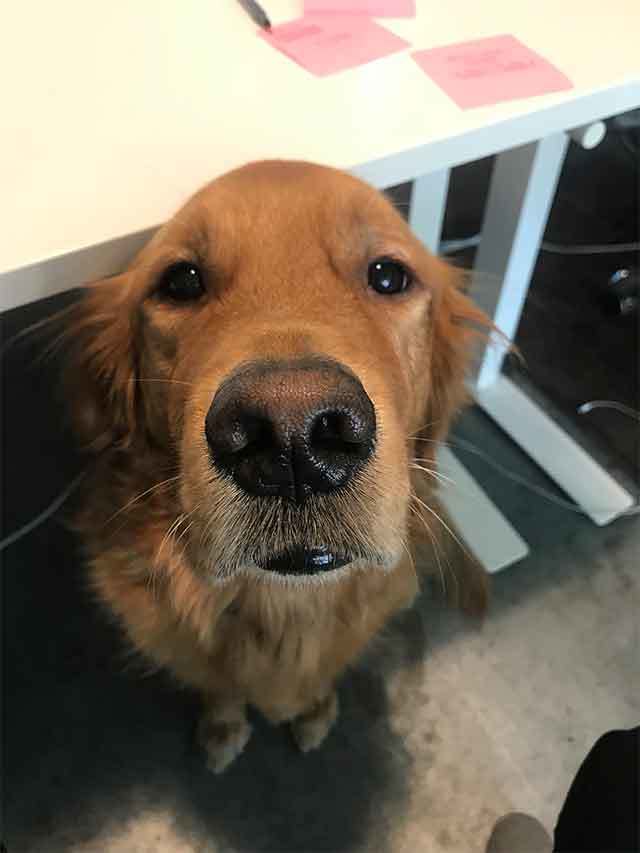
<box><xmin>411</xmin><ymin>35</ymin><xmax>573</xmax><ymax>109</ymax></box>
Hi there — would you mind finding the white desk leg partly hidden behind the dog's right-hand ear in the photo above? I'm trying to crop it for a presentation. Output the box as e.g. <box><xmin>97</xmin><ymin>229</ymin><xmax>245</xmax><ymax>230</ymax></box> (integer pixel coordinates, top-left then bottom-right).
<box><xmin>409</xmin><ymin>169</ymin><xmax>528</xmax><ymax>572</ymax></box>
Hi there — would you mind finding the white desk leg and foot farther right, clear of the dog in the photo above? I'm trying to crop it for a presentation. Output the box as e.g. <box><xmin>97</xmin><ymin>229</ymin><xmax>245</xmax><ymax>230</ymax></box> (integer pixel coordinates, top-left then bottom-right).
<box><xmin>470</xmin><ymin>133</ymin><xmax>635</xmax><ymax>524</ymax></box>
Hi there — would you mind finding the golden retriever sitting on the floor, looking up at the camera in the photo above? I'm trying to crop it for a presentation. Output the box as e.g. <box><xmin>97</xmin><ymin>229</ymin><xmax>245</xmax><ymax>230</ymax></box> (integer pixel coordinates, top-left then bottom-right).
<box><xmin>67</xmin><ymin>161</ymin><xmax>485</xmax><ymax>772</ymax></box>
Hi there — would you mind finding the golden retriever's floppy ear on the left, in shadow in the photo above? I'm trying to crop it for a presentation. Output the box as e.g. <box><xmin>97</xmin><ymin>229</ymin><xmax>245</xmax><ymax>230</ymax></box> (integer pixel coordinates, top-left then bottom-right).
<box><xmin>63</xmin><ymin>273</ymin><xmax>138</xmax><ymax>452</ymax></box>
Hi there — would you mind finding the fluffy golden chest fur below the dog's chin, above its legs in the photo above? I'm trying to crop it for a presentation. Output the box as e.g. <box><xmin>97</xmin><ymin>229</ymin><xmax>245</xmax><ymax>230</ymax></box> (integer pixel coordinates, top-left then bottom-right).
<box><xmin>91</xmin><ymin>536</ymin><xmax>417</xmax><ymax>721</ymax></box>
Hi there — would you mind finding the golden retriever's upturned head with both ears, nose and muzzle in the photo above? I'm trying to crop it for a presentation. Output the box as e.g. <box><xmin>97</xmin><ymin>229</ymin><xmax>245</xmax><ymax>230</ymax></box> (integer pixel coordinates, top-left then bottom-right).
<box><xmin>66</xmin><ymin>162</ymin><xmax>481</xmax><ymax>579</ymax></box>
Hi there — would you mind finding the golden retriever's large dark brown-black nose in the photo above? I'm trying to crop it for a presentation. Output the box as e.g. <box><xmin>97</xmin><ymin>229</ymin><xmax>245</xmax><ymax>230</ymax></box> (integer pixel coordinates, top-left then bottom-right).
<box><xmin>205</xmin><ymin>359</ymin><xmax>376</xmax><ymax>503</ymax></box>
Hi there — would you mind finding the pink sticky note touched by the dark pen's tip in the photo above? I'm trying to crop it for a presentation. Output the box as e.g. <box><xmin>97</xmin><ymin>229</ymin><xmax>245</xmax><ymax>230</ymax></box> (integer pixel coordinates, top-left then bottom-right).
<box><xmin>260</xmin><ymin>15</ymin><xmax>409</xmax><ymax>77</ymax></box>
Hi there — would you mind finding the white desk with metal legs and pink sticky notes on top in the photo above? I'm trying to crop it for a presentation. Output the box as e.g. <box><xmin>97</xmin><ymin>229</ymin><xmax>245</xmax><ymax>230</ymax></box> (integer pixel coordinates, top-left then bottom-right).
<box><xmin>0</xmin><ymin>0</ymin><xmax>640</xmax><ymax>567</ymax></box>
